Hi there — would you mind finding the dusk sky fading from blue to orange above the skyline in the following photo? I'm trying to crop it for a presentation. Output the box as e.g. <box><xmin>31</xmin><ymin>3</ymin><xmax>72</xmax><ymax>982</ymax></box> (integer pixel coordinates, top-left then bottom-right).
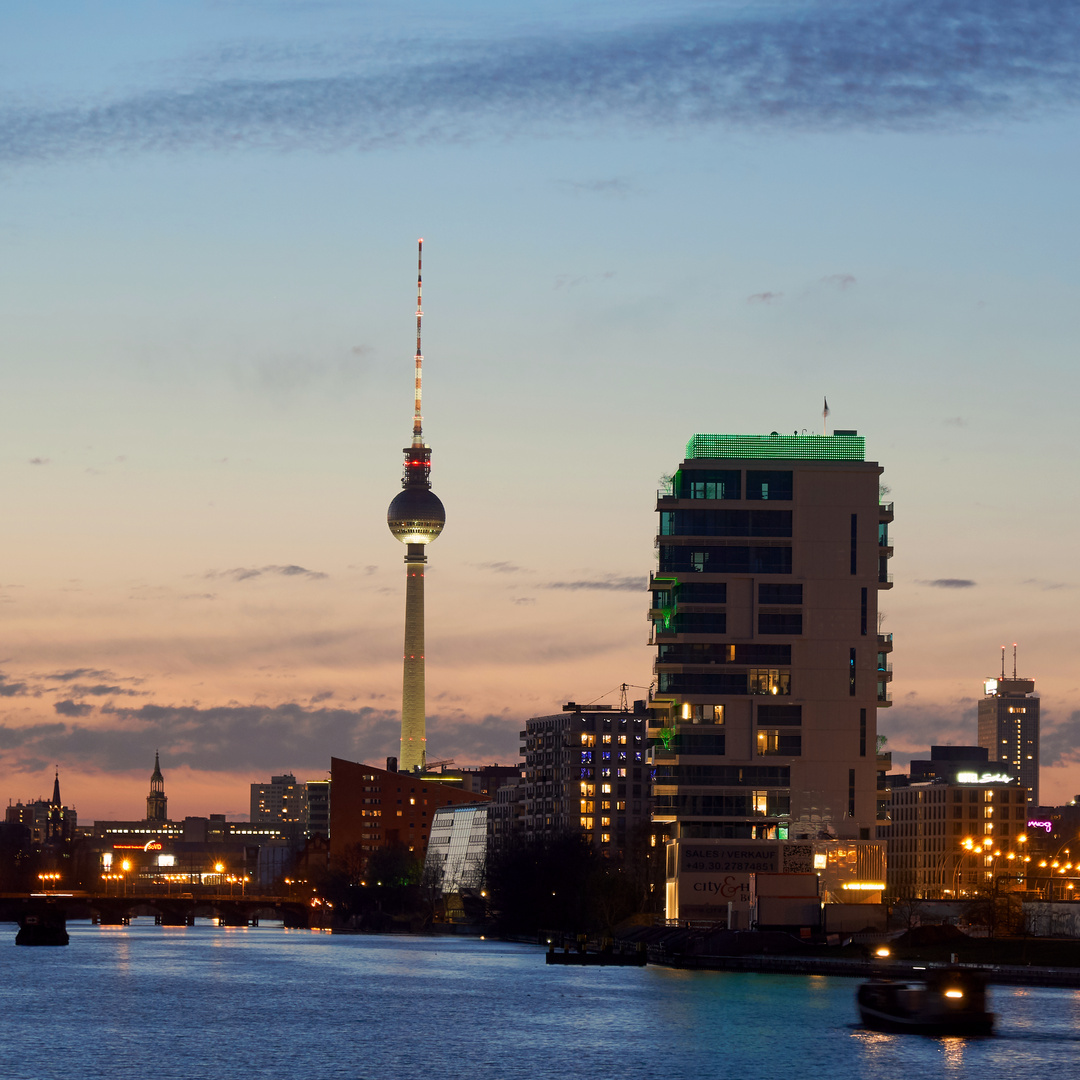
<box><xmin>0</xmin><ymin>0</ymin><xmax>1080</xmax><ymax>820</ymax></box>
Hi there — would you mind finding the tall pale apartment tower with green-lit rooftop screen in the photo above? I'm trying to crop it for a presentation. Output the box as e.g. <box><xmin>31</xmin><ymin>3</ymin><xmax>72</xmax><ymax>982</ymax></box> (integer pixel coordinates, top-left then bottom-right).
<box><xmin>649</xmin><ymin>431</ymin><xmax>892</xmax><ymax>840</ymax></box>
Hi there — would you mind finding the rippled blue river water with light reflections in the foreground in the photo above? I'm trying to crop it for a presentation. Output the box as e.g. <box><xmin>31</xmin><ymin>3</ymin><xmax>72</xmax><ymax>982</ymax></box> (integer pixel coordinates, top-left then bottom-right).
<box><xmin>0</xmin><ymin>919</ymin><xmax>1080</xmax><ymax>1080</ymax></box>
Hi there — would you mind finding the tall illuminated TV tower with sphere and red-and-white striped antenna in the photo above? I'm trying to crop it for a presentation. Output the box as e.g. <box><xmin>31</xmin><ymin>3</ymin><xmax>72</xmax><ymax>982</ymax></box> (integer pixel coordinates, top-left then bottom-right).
<box><xmin>387</xmin><ymin>239</ymin><xmax>446</xmax><ymax>772</ymax></box>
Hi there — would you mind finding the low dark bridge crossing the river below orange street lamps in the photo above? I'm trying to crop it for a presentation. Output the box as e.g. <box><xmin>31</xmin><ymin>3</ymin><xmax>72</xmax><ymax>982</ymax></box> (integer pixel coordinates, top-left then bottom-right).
<box><xmin>0</xmin><ymin>890</ymin><xmax>330</xmax><ymax>930</ymax></box>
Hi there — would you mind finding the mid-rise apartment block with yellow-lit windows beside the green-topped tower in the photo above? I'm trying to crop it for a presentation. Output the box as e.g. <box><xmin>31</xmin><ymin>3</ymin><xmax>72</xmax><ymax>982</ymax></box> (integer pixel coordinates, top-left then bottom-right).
<box><xmin>521</xmin><ymin>701</ymin><xmax>649</xmax><ymax>858</ymax></box>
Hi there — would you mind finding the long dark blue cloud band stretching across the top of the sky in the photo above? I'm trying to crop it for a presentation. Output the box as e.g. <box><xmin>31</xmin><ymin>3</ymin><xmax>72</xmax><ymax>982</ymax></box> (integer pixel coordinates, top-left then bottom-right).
<box><xmin>0</xmin><ymin>0</ymin><xmax>1080</xmax><ymax>165</ymax></box>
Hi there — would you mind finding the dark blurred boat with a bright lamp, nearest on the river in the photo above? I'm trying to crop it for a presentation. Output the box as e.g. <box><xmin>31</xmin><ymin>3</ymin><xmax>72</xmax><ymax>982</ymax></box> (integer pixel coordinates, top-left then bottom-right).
<box><xmin>855</xmin><ymin>968</ymin><xmax>995</xmax><ymax>1035</ymax></box>
